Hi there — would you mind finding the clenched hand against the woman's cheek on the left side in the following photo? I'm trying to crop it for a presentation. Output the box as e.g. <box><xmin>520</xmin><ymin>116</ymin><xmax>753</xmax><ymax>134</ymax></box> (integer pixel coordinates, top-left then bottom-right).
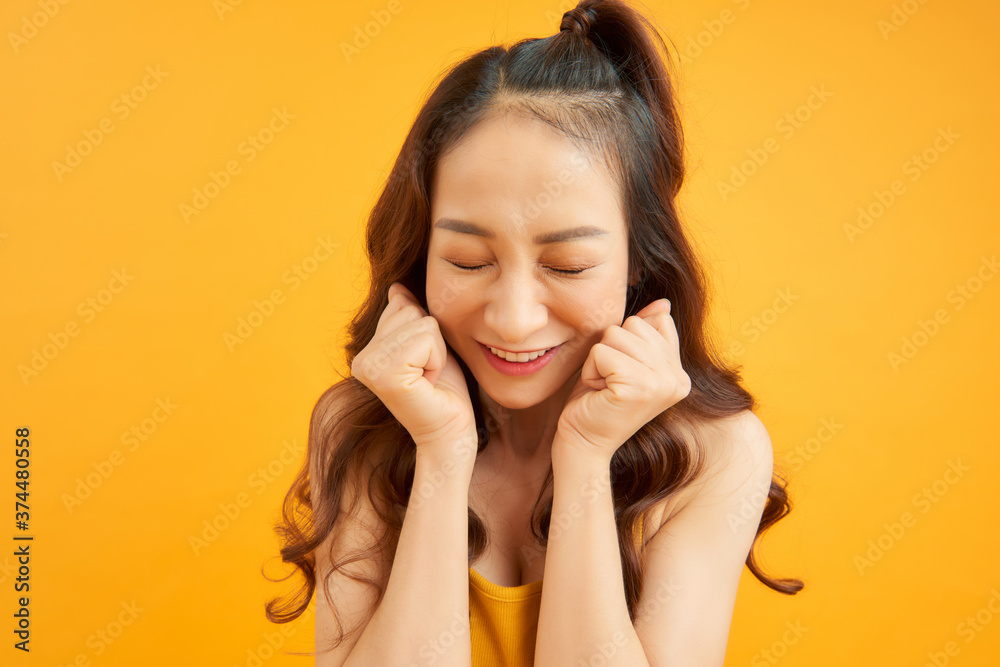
<box><xmin>351</xmin><ymin>282</ymin><xmax>478</xmax><ymax>460</ymax></box>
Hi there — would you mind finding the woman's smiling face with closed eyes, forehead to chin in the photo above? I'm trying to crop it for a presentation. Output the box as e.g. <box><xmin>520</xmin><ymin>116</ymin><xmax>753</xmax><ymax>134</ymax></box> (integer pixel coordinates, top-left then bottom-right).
<box><xmin>426</xmin><ymin>114</ymin><xmax>629</xmax><ymax>409</ymax></box>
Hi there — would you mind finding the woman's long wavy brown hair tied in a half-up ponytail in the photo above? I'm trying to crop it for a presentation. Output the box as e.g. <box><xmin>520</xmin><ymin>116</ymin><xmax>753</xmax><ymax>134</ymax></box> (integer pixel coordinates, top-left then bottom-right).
<box><xmin>266</xmin><ymin>0</ymin><xmax>803</xmax><ymax>656</ymax></box>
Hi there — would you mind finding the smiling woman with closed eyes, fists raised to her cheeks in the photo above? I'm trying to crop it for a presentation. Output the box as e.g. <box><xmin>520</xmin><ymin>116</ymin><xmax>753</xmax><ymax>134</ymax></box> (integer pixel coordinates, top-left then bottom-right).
<box><xmin>267</xmin><ymin>0</ymin><xmax>802</xmax><ymax>667</ymax></box>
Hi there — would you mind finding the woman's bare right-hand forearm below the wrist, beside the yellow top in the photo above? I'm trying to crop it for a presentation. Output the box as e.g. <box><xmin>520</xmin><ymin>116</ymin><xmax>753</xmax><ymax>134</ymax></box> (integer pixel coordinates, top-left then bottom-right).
<box><xmin>534</xmin><ymin>434</ymin><xmax>649</xmax><ymax>667</ymax></box>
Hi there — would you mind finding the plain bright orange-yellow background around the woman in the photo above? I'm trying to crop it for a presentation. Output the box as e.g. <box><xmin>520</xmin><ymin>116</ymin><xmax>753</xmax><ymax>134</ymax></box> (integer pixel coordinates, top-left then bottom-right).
<box><xmin>0</xmin><ymin>0</ymin><xmax>1000</xmax><ymax>667</ymax></box>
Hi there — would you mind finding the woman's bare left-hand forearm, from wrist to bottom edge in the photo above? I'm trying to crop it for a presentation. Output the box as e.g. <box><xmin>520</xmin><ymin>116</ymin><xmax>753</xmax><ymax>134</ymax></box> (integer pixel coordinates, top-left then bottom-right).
<box><xmin>344</xmin><ymin>448</ymin><xmax>474</xmax><ymax>667</ymax></box>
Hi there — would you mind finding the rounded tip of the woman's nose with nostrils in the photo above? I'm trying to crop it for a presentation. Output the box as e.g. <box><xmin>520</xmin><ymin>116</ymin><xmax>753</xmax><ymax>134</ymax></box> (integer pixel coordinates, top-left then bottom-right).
<box><xmin>483</xmin><ymin>274</ymin><xmax>549</xmax><ymax>347</ymax></box>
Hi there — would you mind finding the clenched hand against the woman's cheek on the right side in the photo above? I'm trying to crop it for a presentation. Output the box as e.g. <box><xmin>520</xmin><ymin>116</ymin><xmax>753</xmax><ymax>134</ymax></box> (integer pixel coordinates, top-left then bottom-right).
<box><xmin>556</xmin><ymin>299</ymin><xmax>691</xmax><ymax>462</ymax></box>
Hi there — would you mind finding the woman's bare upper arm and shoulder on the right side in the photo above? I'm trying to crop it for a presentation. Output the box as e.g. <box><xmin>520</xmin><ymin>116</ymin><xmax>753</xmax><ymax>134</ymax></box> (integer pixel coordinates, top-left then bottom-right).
<box><xmin>634</xmin><ymin>411</ymin><xmax>773</xmax><ymax>665</ymax></box>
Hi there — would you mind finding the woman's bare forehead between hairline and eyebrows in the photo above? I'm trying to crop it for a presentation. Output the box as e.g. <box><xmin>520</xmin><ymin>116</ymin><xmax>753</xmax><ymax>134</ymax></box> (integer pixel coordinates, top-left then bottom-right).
<box><xmin>431</xmin><ymin>113</ymin><xmax>624</xmax><ymax>238</ymax></box>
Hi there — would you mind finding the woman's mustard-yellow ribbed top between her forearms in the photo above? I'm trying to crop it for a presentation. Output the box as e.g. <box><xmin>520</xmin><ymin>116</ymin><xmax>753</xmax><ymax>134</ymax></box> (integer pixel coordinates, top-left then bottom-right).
<box><xmin>469</xmin><ymin>521</ymin><xmax>642</xmax><ymax>667</ymax></box>
